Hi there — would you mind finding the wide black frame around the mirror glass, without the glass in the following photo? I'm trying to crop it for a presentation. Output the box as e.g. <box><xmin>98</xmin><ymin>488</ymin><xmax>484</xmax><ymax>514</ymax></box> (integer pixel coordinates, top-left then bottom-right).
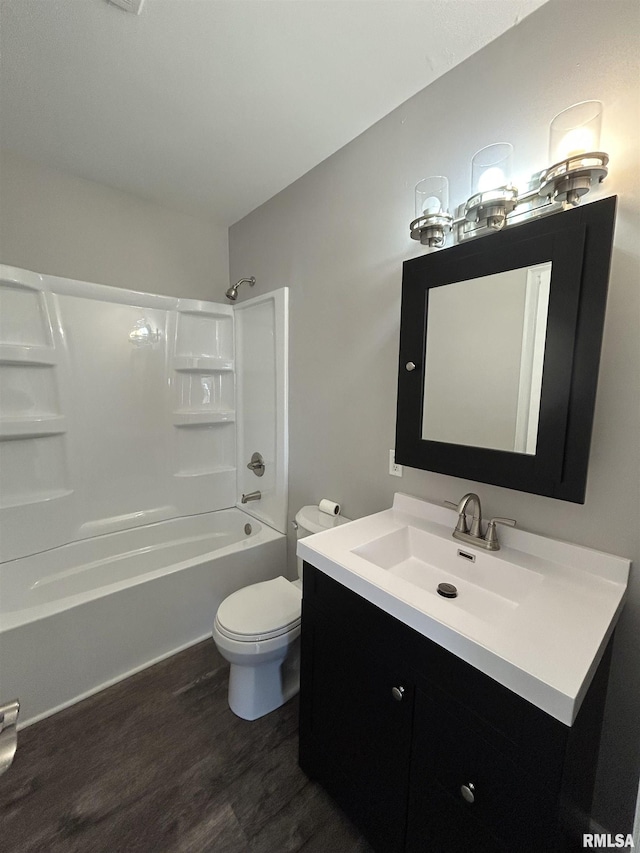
<box><xmin>396</xmin><ymin>196</ymin><xmax>616</xmax><ymax>503</ymax></box>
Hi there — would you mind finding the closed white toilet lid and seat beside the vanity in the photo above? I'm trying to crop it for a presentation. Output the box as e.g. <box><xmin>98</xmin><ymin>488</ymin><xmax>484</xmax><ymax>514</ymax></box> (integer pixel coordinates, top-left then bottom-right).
<box><xmin>216</xmin><ymin>576</ymin><xmax>301</xmax><ymax>643</ymax></box>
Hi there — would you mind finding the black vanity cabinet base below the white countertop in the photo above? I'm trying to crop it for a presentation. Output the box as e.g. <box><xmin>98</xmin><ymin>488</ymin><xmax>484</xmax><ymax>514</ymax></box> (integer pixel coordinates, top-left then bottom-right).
<box><xmin>300</xmin><ymin>563</ymin><xmax>609</xmax><ymax>853</ymax></box>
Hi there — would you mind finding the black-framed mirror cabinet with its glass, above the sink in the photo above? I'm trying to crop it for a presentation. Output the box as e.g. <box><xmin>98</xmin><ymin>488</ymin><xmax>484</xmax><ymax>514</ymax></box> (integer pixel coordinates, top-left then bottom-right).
<box><xmin>396</xmin><ymin>197</ymin><xmax>616</xmax><ymax>503</ymax></box>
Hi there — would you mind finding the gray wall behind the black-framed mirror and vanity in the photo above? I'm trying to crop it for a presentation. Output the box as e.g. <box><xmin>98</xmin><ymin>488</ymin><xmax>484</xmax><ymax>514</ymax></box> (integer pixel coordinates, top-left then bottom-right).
<box><xmin>230</xmin><ymin>0</ymin><xmax>640</xmax><ymax>832</ymax></box>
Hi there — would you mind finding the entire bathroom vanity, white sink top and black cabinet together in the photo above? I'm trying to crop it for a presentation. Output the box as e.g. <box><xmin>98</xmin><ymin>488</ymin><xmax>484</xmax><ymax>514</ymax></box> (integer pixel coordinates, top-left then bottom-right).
<box><xmin>298</xmin><ymin>495</ymin><xmax>629</xmax><ymax>853</ymax></box>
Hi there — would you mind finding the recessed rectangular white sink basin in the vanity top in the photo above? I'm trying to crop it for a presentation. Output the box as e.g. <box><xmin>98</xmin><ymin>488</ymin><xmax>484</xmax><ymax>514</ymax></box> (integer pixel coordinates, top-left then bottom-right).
<box><xmin>352</xmin><ymin>525</ymin><xmax>544</xmax><ymax>624</ymax></box>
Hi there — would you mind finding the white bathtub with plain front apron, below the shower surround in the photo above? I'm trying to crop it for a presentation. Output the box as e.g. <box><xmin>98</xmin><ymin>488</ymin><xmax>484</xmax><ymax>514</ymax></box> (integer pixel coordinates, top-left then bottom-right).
<box><xmin>0</xmin><ymin>509</ymin><xmax>286</xmax><ymax>727</ymax></box>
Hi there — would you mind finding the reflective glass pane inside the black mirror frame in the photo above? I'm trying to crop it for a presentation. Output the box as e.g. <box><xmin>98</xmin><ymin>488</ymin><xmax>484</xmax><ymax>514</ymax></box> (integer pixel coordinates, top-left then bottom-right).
<box><xmin>422</xmin><ymin>261</ymin><xmax>552</xmax><ymax>455</ymax></box>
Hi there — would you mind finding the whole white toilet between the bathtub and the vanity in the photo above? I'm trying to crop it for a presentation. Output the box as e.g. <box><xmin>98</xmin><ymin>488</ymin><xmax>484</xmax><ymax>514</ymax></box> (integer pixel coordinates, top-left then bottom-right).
<box><xmin>213</xmin><ymin>506</ymin><xmax>349</xmax><ymax>720</ymax></box>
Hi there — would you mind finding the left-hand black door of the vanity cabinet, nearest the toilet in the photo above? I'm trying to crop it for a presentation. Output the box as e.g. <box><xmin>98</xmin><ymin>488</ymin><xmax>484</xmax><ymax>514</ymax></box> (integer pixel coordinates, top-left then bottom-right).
<box><xmin>300</xmin><ymin>606</ymin><xmax>414</xmax><ymax>851</ymax></box>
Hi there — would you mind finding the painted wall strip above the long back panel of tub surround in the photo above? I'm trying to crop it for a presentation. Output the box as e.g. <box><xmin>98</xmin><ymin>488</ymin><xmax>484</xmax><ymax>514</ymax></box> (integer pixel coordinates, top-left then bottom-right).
<box><xmin>0</xmin><ymin>150</ymin><xmax>229</xmax><ymax>301</ymax></box>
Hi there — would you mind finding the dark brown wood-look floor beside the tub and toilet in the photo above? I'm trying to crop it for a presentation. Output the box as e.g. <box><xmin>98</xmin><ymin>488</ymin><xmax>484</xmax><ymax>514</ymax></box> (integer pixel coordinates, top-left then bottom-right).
<box><xmin>0</xmin><ymin>641</ymin><xmax>371</xmax><ymax>853</ymax></box>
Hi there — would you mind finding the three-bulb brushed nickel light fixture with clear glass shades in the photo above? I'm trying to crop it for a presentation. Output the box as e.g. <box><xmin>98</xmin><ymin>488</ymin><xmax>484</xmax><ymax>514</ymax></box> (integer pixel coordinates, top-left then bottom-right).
<box><xmin>409</xmin><ymin>101</ymin><xmax>609</xmax><ymax>249</ymax></box>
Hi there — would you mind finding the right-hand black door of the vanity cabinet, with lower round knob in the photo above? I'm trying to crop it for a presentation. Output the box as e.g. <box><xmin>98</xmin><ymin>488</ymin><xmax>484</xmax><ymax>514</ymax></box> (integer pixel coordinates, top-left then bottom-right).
<box><xmin>409</xmin><ymin>690</ymin><xmax>559</xmax><ymax>853</ymax></box>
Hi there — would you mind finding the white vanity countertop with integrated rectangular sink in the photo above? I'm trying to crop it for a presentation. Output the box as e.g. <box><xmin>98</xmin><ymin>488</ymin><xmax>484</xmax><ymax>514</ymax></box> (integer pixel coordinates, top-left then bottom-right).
<box><xmin>297</xmin><ymin>494</ymin><xmax>631</xmax><ymax>725</ymax></box>
